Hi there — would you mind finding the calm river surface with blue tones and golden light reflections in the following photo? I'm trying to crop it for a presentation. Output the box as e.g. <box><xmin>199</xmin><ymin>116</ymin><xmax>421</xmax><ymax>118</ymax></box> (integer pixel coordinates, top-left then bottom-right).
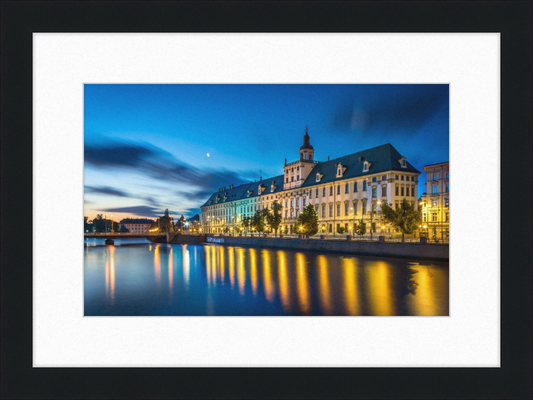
<box><xmin>84</xmin><ymin>239</ymin><xmax>449</xmax><ymax>316</ymax></box>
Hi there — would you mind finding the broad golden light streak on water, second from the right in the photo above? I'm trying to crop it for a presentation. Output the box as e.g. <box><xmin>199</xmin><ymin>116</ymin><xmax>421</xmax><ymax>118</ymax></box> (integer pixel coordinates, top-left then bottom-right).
<box><xmin>367</xmin><ymin>261</ymin><xmax>395</xmax><ymax>316</ymax></box>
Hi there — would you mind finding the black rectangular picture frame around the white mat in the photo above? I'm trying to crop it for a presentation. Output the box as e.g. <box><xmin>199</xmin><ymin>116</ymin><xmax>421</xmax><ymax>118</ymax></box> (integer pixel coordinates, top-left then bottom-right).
<box><xmin>0</xmin><ymin>1</ymin><xmax>533</xmax><ymax>399</ymax></box>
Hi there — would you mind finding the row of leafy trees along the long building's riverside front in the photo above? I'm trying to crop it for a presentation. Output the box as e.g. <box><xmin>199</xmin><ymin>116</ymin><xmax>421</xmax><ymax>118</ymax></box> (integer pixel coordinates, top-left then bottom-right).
<box><xmin>233</xmin><ymin>199</ymin><xmax>422</xmax><ymax>242</ymax></box>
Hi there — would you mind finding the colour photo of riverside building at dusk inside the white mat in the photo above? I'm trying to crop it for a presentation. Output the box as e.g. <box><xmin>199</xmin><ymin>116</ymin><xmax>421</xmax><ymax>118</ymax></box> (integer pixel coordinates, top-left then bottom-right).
<box><xmin>80</xmin><ymin>84</ymin><xmax>451</xmax><ymax>317</ymax></box>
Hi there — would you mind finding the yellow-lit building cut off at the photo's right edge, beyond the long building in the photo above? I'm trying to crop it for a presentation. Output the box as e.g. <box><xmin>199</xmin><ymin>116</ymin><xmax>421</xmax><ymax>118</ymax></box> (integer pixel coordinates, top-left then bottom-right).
<box><xmin>420</xmin><ymin>162</ymin><xmax>450</xmax><ymax>240</ymax></box>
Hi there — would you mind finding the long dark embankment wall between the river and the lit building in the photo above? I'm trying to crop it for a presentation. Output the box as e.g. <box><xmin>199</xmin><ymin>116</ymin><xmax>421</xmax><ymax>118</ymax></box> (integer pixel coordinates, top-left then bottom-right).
<box><xmin>205</xmin><ymin>236</ymin><xmax>450</xmax><ymax>261</ymax></box>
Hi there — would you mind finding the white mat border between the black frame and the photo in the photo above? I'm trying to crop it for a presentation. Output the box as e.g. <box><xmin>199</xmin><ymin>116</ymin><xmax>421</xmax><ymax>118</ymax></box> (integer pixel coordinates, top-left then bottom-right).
<box><xmin>33</xmin><ymin>33</ymin><xmax>500</xmax><ymax>367</ymax></box>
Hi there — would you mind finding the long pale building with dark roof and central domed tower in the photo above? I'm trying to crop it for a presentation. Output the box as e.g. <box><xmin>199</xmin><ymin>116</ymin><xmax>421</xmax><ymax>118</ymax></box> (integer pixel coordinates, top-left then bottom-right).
<box><xmin>201</xmin><ymin>128</ymin><xmax>420</xmax><ymax>235</ymax></box>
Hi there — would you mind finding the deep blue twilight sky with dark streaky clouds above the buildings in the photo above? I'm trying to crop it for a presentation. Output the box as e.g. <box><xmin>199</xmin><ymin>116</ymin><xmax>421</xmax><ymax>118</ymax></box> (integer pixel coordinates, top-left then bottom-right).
<box><xmin>84</xmin><ymin>84</ymin><xmax>449</xmax><ymax>221</ymax></box>
